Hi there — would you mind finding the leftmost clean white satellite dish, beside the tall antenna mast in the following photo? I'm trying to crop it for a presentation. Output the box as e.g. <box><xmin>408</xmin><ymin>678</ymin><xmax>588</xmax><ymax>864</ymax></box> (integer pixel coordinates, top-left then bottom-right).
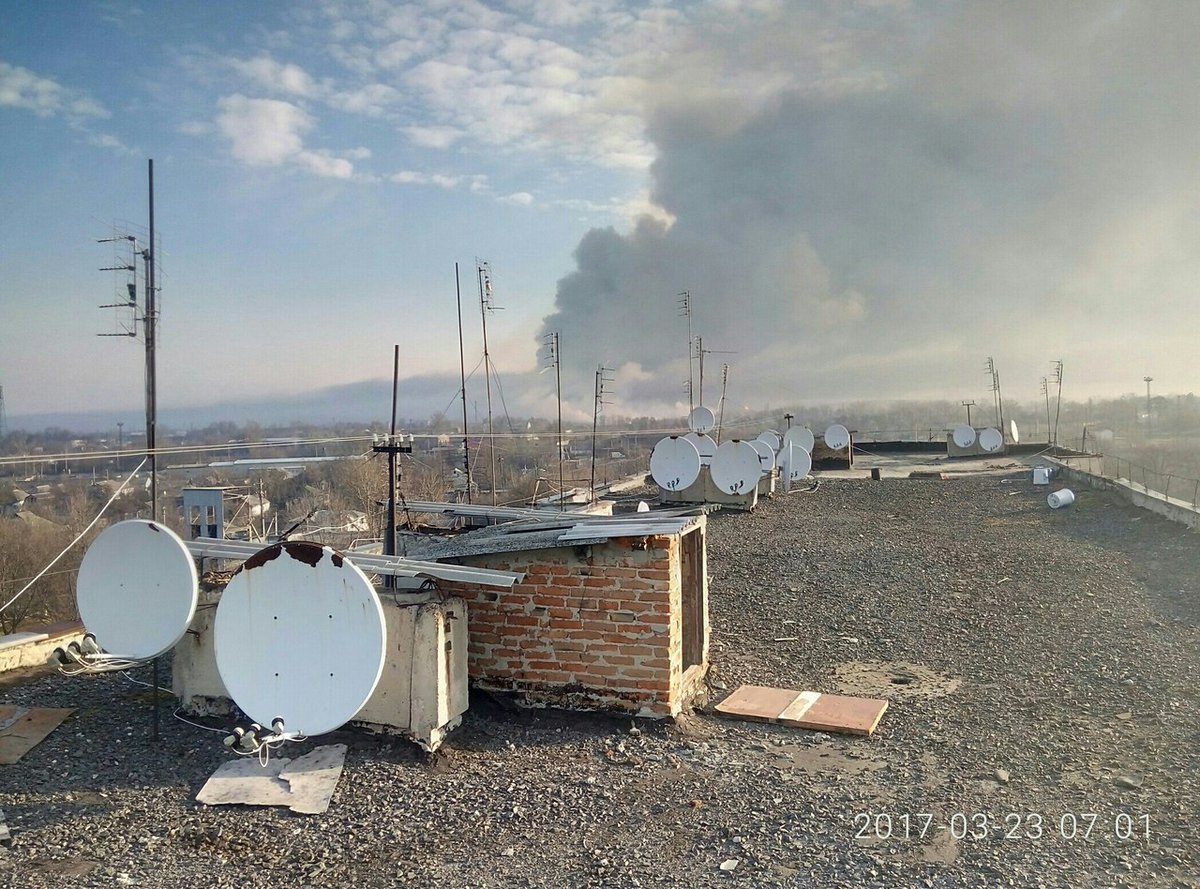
<box><xmin>76</xmin><ymin>518</ymin><xmax>199</xmax><ymax>660</ymax></box>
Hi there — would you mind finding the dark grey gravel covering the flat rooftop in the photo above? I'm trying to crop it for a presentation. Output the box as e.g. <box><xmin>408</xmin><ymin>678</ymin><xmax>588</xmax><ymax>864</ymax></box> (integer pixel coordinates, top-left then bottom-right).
<box><xmin>0</xmin><ymin>473</ymin><xmax>1200</xmax><ymax>889</ymax></box>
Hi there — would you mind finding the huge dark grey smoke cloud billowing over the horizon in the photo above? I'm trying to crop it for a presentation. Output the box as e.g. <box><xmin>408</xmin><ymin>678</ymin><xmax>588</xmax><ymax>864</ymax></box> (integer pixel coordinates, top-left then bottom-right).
<box><xmin>544</xmin><ymin>2</ymin><xmax>1200</xmax><ymax>413</ymax></box>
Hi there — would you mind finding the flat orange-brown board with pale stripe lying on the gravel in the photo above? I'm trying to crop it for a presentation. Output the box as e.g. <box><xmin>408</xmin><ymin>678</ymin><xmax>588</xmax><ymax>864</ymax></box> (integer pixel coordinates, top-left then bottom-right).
<box><xmin>715</xmin><ymin>685</ymin><xmax>888</xmax><ymax>735</ymax></box>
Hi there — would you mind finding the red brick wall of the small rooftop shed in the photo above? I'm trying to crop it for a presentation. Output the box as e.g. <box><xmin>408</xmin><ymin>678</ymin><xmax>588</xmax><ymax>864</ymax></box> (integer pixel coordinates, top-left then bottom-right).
<box><xmin>442</xmin><ymin>527</ymin><xmax>707</xmax><ymax>716</ymax></box>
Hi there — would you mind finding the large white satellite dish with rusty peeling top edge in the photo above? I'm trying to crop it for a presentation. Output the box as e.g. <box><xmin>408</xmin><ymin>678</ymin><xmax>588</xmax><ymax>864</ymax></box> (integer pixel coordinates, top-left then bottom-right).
<box><xmin>214</xmin><ymin>541</ymin><xmax>385</xmax><ymax>735</ymax></box>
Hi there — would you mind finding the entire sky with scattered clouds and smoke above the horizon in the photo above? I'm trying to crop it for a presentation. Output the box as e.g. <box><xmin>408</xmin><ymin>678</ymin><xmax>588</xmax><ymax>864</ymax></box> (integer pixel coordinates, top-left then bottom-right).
<box><xmin>0</xmin><ymin>0</ymin><xmax>1200</xmax><ymax>427</ymax></box>
